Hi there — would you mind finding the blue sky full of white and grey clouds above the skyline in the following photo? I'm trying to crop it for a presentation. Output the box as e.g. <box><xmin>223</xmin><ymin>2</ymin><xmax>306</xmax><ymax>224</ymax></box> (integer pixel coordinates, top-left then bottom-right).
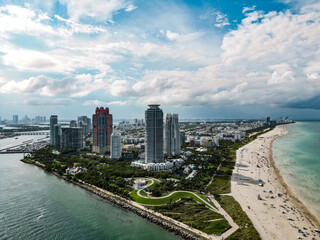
<box><xmin>0</xmin><ymin>0</ymin><xmax>320</xmax><ymax>119</ymax></box>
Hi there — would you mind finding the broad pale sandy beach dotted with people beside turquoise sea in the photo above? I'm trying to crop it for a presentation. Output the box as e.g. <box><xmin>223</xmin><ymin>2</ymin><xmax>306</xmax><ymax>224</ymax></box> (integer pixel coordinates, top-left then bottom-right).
<box><xmin>231</xmin><ymin>125</ymin><xmax>320</xmax><ymax>240</ymax></box>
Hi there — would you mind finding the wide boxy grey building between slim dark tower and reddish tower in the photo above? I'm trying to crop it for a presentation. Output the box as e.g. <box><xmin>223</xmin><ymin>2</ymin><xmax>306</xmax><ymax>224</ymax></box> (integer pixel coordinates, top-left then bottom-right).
<box><xmin>60</xmin><ymin>127</ymin><xmax>83</xmax><ymax>150</ymax></box>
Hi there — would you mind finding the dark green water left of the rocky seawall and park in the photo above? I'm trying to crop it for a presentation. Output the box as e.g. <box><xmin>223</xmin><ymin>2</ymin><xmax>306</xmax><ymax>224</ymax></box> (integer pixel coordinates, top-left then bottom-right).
<box><xmin>0</xmin><ymin>137</ymin><xmax>180</xmax><ymax>240</ymax></box>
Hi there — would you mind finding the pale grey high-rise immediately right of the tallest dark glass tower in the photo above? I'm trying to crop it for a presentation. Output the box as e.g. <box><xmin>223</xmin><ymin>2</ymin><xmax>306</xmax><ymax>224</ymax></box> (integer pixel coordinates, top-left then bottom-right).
<box><xmin>164</xmin><ymin>113</ymin><xmax>181</xmax><ymax>158</ymax></box>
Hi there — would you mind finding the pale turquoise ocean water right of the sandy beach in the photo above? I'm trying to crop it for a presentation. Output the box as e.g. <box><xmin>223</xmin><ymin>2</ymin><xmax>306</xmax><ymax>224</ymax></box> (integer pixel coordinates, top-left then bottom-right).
<box><xmin>273</xmin><ymin>121</ymin><xmax>320</xmax><ymax>219</ymax></box>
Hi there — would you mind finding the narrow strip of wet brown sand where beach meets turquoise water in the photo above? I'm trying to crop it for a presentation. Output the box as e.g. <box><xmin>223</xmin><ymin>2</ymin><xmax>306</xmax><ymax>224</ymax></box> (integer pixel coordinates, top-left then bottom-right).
<box><xmin>269</xmin><ymin>125</ymin><xmax>320</xmax><ymax>228</ymax></box>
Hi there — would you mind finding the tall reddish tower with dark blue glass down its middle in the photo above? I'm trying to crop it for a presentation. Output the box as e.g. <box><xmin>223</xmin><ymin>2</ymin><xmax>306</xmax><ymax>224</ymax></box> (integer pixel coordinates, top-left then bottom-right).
<box><xmin>92</xmin><ymin>107</ymin><xmax>112</xmax><ymax>154</ymax></box>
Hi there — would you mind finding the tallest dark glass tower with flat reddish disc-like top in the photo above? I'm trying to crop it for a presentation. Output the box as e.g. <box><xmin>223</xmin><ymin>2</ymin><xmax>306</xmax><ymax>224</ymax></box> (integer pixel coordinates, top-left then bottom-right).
<box><xmin>145</xmin><ymin>104</ymin><xmax>164</xmax><ymax>163</ymax></box>
